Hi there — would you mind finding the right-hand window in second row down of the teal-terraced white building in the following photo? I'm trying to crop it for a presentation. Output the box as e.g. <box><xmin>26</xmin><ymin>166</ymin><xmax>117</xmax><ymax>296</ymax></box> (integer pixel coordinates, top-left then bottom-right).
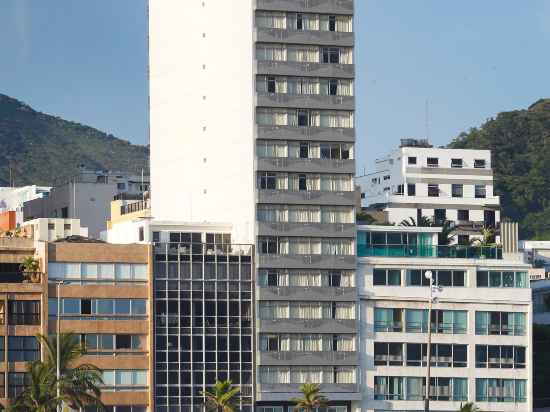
<box><xmin>476</xmin><ymin>312</ymin><xmax>526</xmax><ymax>336</ymax></box>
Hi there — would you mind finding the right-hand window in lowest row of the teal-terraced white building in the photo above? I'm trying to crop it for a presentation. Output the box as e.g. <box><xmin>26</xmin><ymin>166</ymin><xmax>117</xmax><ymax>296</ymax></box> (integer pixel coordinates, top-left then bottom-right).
<box><xmin>476</xmin><ymin>378</ymin><xmax>527</xmax><ymax>403</ymax></box>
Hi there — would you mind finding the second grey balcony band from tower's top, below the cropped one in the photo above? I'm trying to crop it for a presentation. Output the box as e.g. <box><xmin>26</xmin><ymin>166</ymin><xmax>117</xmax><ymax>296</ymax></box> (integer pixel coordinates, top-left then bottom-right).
<box><xmin>256</xmin><ymin>28</ymin><xmax>354</xmax><ymax>47</ymax></box>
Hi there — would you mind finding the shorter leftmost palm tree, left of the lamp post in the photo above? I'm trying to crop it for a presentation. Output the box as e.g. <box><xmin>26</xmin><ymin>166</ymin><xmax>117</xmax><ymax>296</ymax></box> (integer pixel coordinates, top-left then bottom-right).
<box><xmin>7</xmin><ymin>361</ymin><xmax>61</xmax><ymax>412</ymax></box>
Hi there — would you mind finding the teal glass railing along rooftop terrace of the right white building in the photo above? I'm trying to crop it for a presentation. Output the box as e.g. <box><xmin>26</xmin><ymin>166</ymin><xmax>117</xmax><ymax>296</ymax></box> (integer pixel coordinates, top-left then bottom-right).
<box><xmin>357</xmin><ymin>244</ymin><xmax>502</xmax><ymax>259</ymax></box>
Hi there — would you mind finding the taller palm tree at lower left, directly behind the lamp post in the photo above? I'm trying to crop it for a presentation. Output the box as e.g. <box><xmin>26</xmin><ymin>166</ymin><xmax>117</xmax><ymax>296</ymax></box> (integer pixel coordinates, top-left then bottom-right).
<box><xmin>38</xmin><ymin>333</ymin><xmax>105</xmax><ymax>410</ymax></box>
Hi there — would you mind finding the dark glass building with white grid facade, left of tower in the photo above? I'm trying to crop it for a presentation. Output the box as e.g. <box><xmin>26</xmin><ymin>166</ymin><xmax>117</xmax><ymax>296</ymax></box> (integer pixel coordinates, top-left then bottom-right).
<box><xmin>153</xmin><ymin>237</ymin><xmax>254</xmax><ymax>412</ymax></box>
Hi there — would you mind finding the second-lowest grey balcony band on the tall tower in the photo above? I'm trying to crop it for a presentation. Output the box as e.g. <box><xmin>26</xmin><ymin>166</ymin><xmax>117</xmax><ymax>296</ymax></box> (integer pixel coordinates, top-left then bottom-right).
<box><xmin>259</xmin><ymin>352</ymin><xmax>359</xmax><ymax>366</ymax></box>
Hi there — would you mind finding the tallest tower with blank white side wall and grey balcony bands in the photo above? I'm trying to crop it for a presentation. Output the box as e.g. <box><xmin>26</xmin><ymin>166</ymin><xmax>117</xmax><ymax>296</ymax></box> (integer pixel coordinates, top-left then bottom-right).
<box><xmin>149</xmin><ymin>0</ymin><xmax>360</xmax><ymax>412</ymax></box>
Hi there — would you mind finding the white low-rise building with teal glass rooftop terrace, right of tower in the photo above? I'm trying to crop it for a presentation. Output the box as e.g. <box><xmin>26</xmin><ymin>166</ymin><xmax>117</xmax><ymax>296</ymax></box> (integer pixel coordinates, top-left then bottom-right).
<box><xmin>357</xmin><ymin>226</ymin><xmax>533</xmax><ymax>412</ymax></box>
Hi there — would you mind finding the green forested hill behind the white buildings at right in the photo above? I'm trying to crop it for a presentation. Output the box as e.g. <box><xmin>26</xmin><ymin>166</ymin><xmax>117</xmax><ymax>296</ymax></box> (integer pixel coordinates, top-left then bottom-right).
<box><xmin>449</xmin><ymin>99</ymin><xmax>550</xmax><ymax>240</ymax></box>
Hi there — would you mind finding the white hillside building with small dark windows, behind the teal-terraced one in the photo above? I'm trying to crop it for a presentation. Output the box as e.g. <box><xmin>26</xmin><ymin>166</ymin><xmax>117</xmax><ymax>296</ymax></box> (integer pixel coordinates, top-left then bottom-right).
<box><xmin>356</xmin><ymin>140</ymin><xmax>500</xmax><ymax>243</ymax></box>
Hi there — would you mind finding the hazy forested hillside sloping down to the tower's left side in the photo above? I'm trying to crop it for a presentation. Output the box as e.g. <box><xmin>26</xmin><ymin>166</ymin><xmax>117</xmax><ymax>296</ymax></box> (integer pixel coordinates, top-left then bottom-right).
<box><xmin>0</xmin><ymin>94</ymin><xmax>149</xmax><ymax>186</ymax></box>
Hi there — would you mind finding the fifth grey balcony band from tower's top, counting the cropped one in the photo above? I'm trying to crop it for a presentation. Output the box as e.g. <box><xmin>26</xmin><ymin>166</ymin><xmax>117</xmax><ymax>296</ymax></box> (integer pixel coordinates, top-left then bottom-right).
<box><xmin>256</xmin><ymin>125</ymin><xmax>355</xmax><ymax>143</ymax></box>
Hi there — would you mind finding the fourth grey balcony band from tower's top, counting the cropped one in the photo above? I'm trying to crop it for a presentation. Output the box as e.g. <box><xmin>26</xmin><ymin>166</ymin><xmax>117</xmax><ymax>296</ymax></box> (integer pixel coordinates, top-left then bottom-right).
<box><xmin>256</xmin><ymin>93</ymin><xmax>355</xmax><ymax>110</ymax></box>
